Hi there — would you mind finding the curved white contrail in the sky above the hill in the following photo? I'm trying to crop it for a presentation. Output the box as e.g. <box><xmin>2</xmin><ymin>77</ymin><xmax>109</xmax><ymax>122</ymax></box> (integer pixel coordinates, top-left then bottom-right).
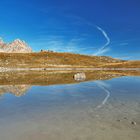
<box><xmin>94</xmin><ymin>26</ymin><xmax>110</xmax><ymax>55</ymax></box>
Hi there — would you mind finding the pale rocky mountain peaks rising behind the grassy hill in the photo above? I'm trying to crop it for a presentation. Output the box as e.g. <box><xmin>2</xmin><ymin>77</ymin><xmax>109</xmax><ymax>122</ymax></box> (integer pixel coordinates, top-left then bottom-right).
<box><xmin>0</xmin><ymin>38</ymin><xmax>32</xmax><ymax>53</ymax></box>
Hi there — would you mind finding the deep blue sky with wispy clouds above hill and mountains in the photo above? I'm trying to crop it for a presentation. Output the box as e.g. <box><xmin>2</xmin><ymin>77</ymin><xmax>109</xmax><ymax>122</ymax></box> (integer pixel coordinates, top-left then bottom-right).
<box><xmin>0</xmin><ymin>0</ymin><xmax>140</xmax><ymax>59</ymax></box>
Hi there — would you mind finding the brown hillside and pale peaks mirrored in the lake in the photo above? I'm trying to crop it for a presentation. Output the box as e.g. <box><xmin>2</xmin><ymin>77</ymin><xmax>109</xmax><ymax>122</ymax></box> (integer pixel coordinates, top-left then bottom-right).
<box><xmin>0</xmin><ymin>71</ymin><xmax>140</xmax><ymax>96</ymax></box>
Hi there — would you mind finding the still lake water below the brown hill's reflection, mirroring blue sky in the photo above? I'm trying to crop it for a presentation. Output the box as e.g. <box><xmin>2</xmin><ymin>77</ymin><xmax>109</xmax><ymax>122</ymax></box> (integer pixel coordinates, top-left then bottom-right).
<box><xmin>0</xmin><ymin>72</ymin><xmax>140</xmax><ymax>140</ymax></box>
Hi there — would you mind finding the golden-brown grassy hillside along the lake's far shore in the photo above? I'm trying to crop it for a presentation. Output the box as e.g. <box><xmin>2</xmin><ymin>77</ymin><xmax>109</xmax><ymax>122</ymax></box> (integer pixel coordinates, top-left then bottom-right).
<box><xmin>0</xmin><ymin>52</ymin><xmax>140</xmax><ymax>68</ymax></box>
